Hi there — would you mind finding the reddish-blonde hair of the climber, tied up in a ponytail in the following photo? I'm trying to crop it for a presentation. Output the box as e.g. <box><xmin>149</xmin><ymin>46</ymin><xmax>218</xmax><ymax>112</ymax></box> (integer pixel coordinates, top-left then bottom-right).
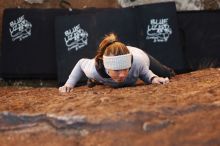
<box><xmin>95</xmin><ymin>33</ymin><xmax>129</xmax><ymax>61</ymax></box>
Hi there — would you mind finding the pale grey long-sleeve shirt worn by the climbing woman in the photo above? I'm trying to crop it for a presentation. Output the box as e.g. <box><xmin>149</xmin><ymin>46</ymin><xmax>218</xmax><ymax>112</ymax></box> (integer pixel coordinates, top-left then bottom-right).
<box><xmin>66</xmin><ymin>46</ymin><xmax>156</xmax><ymax>87</ymax></box>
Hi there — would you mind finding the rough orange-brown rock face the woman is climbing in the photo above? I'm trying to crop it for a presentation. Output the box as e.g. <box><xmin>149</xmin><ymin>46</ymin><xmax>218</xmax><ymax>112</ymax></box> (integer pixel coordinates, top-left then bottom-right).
<box><xmin>0</xmin><ymin>68</ymin><xmax>220</xmax><ymax>146</ymax></box>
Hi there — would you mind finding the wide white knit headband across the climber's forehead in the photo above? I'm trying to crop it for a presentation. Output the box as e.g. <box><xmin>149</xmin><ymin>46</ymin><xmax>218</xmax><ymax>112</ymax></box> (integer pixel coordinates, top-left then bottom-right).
<box><xmin>103</xmin><ymin>53</ymin><xmax>131</xmax><ymax>70</ymax></box>
